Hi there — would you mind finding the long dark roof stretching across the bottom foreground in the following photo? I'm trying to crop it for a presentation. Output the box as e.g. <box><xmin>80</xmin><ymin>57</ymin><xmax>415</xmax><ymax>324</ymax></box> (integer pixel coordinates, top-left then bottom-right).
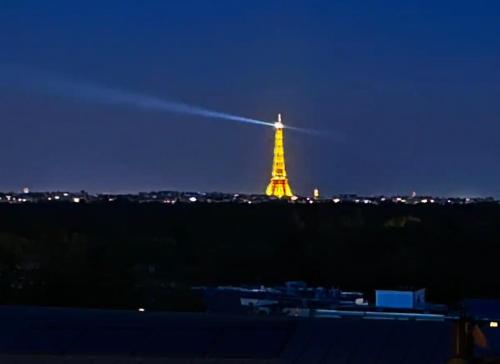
<box><xmin>0</xmin><ymin>307</ymin><xmax>453</xmax><ymax>364</ymax></box>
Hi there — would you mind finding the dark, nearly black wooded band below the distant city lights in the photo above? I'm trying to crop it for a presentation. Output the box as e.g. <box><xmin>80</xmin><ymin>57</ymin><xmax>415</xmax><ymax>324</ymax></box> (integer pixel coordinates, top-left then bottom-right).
<box><xmin>0</xmin><ymin>202</ymin><xmax>500</xmax><ymax>310</ymax></box>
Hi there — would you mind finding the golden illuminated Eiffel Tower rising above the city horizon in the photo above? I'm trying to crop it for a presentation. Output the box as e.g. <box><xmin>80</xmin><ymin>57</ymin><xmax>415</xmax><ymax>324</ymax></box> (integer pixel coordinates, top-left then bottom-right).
<box><xmin>266</xmin><ymin>114</ymin><xmax>293</xmax><ymax>198</ymax></box>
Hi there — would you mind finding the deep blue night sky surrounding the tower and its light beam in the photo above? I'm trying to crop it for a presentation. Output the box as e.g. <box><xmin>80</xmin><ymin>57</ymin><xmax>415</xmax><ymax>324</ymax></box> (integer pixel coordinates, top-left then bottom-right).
<box><xmin>0</xmin><ymin>0</ymin><xmax>500</xmax><ymax>196</ymax></box>
